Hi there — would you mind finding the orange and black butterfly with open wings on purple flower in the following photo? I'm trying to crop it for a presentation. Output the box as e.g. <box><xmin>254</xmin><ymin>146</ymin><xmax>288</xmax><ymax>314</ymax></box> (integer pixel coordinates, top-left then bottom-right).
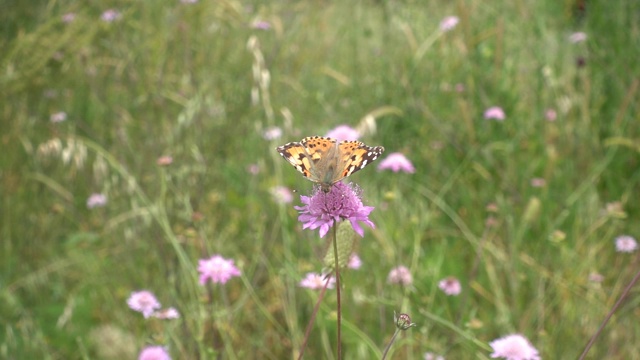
<box><xmin>276</xmin><ymin>136</ymin><xmax>384</xmax><ymax>192</ymax></box>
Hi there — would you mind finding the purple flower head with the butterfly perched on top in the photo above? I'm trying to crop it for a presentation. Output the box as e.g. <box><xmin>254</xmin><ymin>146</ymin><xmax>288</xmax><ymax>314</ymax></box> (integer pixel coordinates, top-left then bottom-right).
<box><xmin>295</xmin><ymin>182</ymin><xmax>375</xmax><ymax>237</ymax></box>
